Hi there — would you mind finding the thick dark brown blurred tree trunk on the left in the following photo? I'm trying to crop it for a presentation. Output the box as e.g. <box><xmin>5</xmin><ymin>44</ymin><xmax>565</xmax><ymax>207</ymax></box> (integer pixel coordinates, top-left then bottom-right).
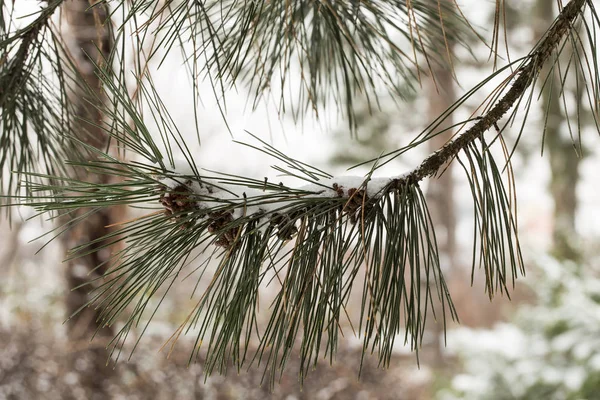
<box><xmin>62</xmin><ymin>0</ymin><xmax>117</xmax><ymax>398</ymax></box>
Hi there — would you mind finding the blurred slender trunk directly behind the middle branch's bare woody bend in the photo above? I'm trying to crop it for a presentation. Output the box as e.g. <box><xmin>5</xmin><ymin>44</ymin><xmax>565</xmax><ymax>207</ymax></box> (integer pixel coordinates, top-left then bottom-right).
<box><xmin>425</xmin><ymin>0</ymin><xmax>456</xmax><ymax>365</ymax></box>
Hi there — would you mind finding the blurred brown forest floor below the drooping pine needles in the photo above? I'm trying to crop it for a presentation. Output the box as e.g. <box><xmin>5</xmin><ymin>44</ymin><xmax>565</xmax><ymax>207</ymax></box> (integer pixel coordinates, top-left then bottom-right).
<box><xmin>0</xmin><ymin>330</ymin><xmax>438</xmax><ymax>400</ymax></box>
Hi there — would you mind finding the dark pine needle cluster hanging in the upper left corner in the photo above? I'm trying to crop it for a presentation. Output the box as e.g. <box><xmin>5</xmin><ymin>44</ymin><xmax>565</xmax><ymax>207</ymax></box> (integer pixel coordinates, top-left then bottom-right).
<box><xmin>0</xmin><ymin>0</ymin><xmax>78</xmax><ymax>200</ymax></box>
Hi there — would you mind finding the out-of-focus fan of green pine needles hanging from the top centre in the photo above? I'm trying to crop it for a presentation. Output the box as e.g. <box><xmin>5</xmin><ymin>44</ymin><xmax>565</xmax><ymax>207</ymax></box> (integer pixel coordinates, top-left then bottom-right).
<box><xmin>111</xmin><ymin>0</ymin><xmax>470</xmax><ymax>130</ymax></box>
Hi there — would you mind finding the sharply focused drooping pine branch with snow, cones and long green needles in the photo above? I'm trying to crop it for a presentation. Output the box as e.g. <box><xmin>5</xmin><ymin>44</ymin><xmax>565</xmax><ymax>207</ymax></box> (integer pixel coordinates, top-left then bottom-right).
<box><xmin>5</xmin><ymin>0</ymin><xmax>591</xmax><ymax>382</ymax></box>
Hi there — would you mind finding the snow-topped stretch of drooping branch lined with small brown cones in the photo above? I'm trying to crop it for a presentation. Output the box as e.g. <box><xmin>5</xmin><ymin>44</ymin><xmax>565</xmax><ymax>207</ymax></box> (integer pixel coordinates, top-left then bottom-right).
<box><xmin>159</xmin><ymin>176</ymin><xmax>391</xmax><ymax>248</ymax></box>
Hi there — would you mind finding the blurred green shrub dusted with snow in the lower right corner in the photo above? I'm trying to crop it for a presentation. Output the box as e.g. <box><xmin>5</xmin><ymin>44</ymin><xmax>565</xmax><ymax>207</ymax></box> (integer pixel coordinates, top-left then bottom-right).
<box><xmin>438</xmin><ymin>258</ymin><xmax>600</xmax><ymax>400</ymax></box>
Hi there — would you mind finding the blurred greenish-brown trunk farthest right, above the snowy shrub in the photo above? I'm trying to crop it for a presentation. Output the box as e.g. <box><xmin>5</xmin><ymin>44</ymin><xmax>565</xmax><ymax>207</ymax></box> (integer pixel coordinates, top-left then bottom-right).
<box><xmin>535</xmin><ymin>0</ymin><xmax>581</xmax><ymax>260</ymax></box>
